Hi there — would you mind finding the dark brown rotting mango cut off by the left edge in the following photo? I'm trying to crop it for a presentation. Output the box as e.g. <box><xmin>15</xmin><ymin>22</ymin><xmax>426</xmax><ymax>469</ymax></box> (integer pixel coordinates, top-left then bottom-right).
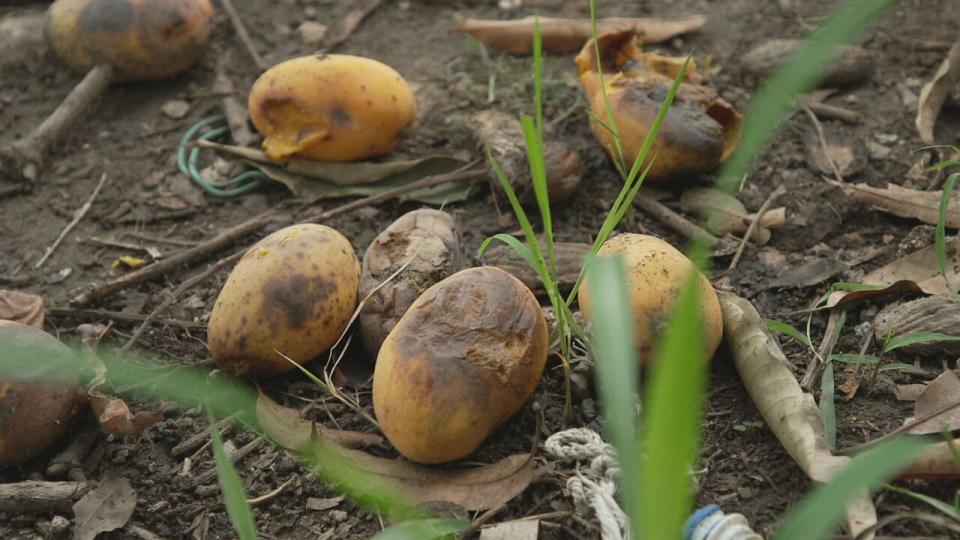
<box><xmin>0</xmin><ymin>320</ymin><xmax>79</xmax><ymax>466</ymax></box>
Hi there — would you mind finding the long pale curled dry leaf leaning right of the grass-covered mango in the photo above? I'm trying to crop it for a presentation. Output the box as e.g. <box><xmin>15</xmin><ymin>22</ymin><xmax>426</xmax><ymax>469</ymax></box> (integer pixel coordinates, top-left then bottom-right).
<box><xmin>718</xmin><ymin>292</ymin><xmax>877</xmax><ymax>536</ymax></box>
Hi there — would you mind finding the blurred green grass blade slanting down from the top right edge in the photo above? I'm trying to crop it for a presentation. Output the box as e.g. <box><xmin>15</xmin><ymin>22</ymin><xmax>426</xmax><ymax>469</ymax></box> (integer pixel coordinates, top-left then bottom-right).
<box><xmin>717</xmin><ymin>0</ymin><xmax>896</xmax><ymax>193</ymax></box>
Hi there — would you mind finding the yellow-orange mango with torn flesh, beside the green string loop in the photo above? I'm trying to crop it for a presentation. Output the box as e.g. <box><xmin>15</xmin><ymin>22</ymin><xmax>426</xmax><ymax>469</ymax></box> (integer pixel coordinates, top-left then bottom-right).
<box><xmin>248</xmin><ymin>54</ymin><xmax>417</xmax><ymax>161</ymax></box>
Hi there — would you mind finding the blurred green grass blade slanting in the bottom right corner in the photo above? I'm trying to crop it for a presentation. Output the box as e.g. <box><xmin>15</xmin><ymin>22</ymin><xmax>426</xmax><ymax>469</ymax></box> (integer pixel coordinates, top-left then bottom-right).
<box><xmin>774</xmin><ymin>439</ymin><xmax>927</xmax><ymax>540</ymax></box>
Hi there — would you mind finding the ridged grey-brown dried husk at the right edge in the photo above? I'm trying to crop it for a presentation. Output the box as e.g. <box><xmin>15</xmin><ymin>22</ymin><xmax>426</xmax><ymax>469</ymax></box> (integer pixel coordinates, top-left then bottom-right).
<box><xmin>873</xmin><ymin>295</ymin><xmax>960</xmax><ymax>359</ymax></box>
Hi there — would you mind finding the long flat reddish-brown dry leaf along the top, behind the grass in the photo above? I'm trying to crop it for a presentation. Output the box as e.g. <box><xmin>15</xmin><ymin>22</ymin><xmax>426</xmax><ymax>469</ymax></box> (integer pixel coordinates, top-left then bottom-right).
<box><xmin>456</xmin><ymin>15</ymin><xmax>707</xmax><ymax>54</ymax></box>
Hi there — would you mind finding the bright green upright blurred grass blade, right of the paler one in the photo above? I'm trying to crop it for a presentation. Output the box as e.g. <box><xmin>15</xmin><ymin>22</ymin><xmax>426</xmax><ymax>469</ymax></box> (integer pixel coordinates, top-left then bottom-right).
<box><xmin>635</xmin><ymin>248</ymin><xmax>707</xmax><ymax>538</ymax></box>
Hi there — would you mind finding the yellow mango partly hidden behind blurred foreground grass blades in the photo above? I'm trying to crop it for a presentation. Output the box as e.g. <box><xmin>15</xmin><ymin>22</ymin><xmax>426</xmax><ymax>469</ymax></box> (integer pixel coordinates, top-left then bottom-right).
<box><xmin>577</xmin><ymin>234</ymin><xmax>723</xmax><ymax>366</ymax></box>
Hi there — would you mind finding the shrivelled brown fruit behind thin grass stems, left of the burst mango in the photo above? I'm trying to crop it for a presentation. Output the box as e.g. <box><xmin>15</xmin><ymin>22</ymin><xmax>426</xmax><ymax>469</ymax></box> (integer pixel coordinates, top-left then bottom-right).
<box><xmin>467</xmin><ymin>110</ymin><xmax>583</xmax><ymax>205</ymax></box>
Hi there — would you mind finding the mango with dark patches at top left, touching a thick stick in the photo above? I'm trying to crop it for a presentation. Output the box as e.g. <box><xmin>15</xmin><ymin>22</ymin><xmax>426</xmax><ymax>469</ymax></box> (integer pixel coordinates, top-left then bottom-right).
<box><xmin>46</xmin><ymin>0</ymin><xmax>213</xmax><ymax>81</ymax></box>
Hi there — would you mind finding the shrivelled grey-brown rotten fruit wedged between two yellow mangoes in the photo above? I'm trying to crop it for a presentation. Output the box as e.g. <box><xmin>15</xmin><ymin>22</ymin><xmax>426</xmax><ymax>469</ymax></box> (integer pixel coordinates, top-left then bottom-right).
<box><xmin>360</xmin><ymin>208</ymin><xmax>466</xmax><ymax>357</ymax></box>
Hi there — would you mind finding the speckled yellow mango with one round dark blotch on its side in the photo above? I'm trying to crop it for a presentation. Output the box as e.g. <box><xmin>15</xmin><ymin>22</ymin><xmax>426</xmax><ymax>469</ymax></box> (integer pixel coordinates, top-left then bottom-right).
<box><xmin>207</xmin><ymin>224</ymin><xmax>360</xmax><ymax>379</ymax></box>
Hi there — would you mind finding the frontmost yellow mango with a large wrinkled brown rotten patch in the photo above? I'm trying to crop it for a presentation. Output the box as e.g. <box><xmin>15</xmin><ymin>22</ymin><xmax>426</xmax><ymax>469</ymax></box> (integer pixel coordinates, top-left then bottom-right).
<box><xmin>373</xmin><ymin>266</ymin><xmax>548</xmax><ymax>463</ymax></box>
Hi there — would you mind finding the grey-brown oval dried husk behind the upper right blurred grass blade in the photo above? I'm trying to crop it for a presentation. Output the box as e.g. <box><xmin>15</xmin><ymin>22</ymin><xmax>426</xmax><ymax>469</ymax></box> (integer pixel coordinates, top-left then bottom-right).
<box><xmin>740</xmin><ymin>39</ymin><xmax>874</xmax><ymax>86</ymax></box>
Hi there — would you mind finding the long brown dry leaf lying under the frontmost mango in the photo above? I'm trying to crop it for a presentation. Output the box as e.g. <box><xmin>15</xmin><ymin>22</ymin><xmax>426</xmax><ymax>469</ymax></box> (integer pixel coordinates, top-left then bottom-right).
<box><xmin>257</xmin><ymin>394</ymin><xmax>537</xmax><ymax>511</ymax></box>
